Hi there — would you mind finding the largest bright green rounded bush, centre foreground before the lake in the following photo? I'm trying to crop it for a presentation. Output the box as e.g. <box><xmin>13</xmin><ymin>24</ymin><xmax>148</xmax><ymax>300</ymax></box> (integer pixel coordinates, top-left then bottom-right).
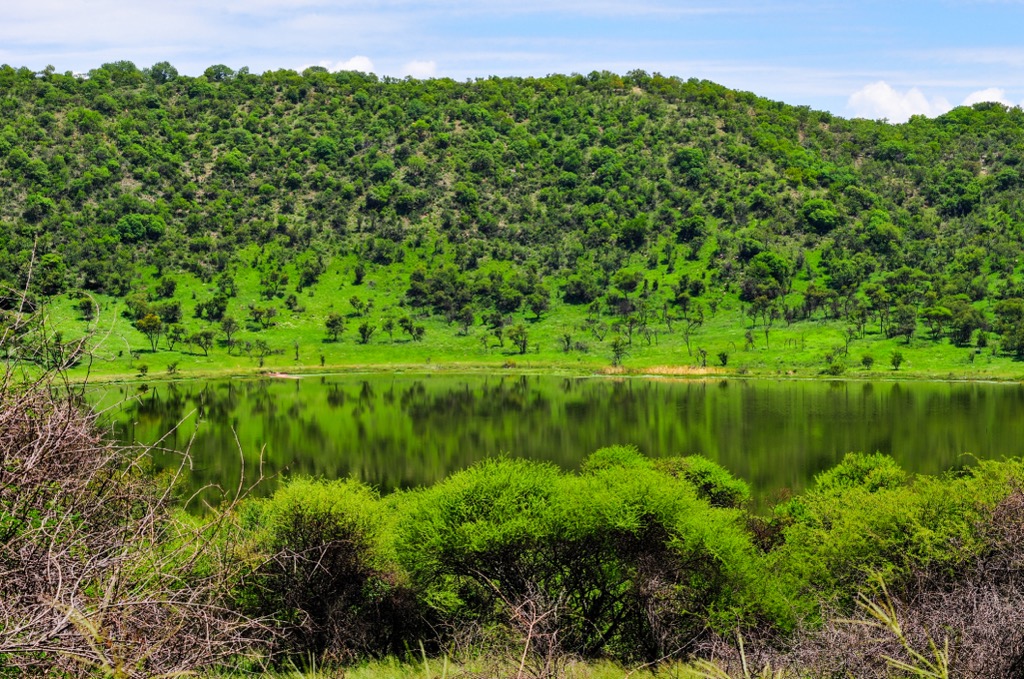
<box><xmin>396</xmin><ymin>449</ymin><xmax>787</xmax><ymax>659</ymax></box>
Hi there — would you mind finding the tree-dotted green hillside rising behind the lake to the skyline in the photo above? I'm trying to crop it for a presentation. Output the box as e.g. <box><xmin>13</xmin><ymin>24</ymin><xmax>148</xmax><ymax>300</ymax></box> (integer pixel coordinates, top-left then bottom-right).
<box><xmin>0</xmin><ymin>61</ymin><xmax>1024</xmax><ymax>377</ymax></box>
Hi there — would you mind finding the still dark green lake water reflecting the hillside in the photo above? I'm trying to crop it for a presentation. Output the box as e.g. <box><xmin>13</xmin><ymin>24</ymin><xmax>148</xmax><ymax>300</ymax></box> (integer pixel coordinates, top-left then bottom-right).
<box><xmin>92</xmin><ymin>374</ymin><xmax>1024</xmax><ymax>501</ymax></box>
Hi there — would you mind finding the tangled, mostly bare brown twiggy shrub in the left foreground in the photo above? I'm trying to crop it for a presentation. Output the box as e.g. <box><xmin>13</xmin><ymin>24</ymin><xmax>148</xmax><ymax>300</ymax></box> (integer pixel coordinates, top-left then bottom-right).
<box><xmin>0</xmin><ymin>336</ymin><xmax>260</xmax><ymax>677</ymax></box>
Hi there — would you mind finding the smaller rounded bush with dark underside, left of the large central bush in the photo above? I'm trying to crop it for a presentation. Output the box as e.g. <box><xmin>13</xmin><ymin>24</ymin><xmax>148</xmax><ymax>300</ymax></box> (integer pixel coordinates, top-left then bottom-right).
<box><xmin>238</xmin><ymin>478</ymin><xmax>420</xmax><ymax>661</ymax></box>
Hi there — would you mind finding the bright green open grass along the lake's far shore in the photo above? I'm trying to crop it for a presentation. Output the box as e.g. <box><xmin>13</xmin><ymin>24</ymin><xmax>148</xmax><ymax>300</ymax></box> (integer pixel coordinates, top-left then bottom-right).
<box><xmin>41</xmin><ymin>244</ymin><xmax>1024</xmax><ymax>381</ymax></box>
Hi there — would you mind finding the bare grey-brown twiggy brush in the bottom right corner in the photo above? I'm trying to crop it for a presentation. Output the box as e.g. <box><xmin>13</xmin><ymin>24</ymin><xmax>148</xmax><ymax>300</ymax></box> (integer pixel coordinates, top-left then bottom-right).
<box><xmin>772</xmin><ymin>489</ymin><xmax>1024</xmax><ymax>677</ymax></box>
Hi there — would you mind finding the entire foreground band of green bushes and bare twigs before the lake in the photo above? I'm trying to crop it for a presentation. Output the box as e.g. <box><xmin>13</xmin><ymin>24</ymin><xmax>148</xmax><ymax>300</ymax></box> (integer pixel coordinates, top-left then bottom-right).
<box><xmin>6</xmin><ymin>329</ymin><xmax>1024</xmax><ymax>677</ymax></box>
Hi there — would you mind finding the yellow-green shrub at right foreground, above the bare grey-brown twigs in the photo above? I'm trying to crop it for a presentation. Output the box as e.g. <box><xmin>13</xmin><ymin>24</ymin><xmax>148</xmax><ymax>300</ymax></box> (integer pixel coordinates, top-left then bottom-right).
<box><xmin>769</xmin><ymin>455</ymin><xmax>1024</xmax><ymax>605</ymax></box>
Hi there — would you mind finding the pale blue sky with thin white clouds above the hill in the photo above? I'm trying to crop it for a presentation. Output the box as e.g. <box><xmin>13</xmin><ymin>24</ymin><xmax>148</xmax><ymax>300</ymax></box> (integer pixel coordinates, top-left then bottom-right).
<box><xmin>0</xmin><ymin>0</ymin><xmax>1024</xmax><ymax>122</ymax></box>
